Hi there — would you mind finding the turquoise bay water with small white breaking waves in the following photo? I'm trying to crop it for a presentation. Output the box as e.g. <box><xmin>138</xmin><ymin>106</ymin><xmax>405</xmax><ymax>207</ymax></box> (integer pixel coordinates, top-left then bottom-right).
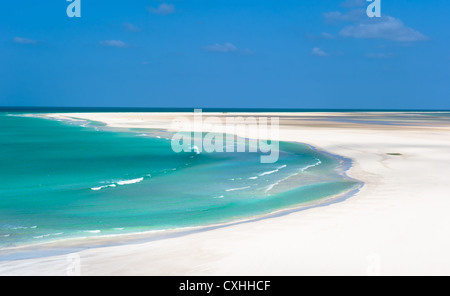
<box><xmin>0</xmin><ymin>113</ymin><xmax>358</xmax><ymax>247</ymax></box>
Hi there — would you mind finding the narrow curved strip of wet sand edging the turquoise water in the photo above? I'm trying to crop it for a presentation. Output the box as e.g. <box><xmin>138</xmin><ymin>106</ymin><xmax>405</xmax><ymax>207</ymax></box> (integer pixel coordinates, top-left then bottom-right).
<box><xmin>0</xmin><ymin>114</ymin><xmax>364</xmax><ymax>262</ymax></box>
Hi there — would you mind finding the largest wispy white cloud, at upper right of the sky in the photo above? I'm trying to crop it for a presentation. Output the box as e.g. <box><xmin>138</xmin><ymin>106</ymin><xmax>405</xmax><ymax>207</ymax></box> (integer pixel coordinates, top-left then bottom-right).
<box><xmin>339</xmin><ymin>16</ymin><xmax>428</xmax><ymax>42</ymax></box>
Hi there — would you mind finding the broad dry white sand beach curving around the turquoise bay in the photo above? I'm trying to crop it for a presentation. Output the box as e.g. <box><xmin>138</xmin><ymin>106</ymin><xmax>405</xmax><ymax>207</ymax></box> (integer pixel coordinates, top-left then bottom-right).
<box><xmin>0</xmin><ymin>113</ymin><xmax>450</xmax><ymax>275</ymax></box>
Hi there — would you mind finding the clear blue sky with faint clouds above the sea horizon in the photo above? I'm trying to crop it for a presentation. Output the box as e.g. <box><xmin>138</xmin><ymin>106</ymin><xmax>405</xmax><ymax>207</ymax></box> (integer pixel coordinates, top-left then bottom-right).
<box><xmin>0</xmin><ymin>0</ymin><xmax>450</xmax><ymax>109</ymax></box>
